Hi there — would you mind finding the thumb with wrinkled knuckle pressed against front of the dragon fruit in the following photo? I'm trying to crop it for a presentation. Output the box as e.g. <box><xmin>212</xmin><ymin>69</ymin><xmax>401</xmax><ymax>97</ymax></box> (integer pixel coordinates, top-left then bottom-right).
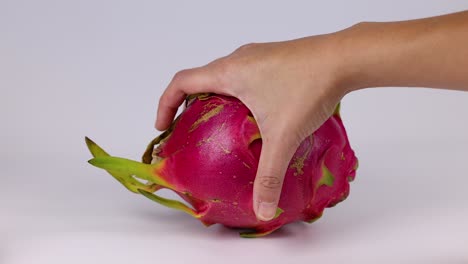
<box><xmin>253</xmin><ymin>137</ymin><xmax>295</xmax><ymax>221</ymax></box>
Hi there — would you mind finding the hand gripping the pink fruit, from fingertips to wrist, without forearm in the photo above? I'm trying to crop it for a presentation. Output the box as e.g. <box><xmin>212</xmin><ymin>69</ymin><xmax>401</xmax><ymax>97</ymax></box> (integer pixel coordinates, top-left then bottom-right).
<box><xmin>156</xmin><ymin>34</ymin><xmax>352</xmax><ymax>221</ymax></box>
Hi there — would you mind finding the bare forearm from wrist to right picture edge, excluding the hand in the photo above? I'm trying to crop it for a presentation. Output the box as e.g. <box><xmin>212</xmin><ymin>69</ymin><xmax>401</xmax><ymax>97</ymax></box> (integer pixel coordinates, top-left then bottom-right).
<box><xmin>337</xmin><ymin>11</ymin><xmax>468</xmax><ymax>91</ymax></box>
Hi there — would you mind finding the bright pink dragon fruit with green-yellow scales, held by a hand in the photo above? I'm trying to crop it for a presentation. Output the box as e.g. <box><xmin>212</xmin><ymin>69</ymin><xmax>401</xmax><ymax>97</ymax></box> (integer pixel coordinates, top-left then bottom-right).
<box><xmin>86</xmin><ymin>94</ymin><xmax>358</xmax><ymax>237</ymax></box>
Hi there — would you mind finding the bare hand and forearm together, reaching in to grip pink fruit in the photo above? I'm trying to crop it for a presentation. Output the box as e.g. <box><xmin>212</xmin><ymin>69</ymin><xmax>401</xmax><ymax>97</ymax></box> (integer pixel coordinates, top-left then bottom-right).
<box><xmin>156</xmin><ymin>11</ymin><xmax>468</xmax><ymax>221</ymax></box>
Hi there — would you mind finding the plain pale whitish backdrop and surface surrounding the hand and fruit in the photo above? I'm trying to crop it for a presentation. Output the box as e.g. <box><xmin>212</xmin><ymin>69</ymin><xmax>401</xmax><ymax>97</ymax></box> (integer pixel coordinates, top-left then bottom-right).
<box><xmin>0</xmin><ymin>0</ymin><xmax>468</xmax><ymax>264</ymax></box>
